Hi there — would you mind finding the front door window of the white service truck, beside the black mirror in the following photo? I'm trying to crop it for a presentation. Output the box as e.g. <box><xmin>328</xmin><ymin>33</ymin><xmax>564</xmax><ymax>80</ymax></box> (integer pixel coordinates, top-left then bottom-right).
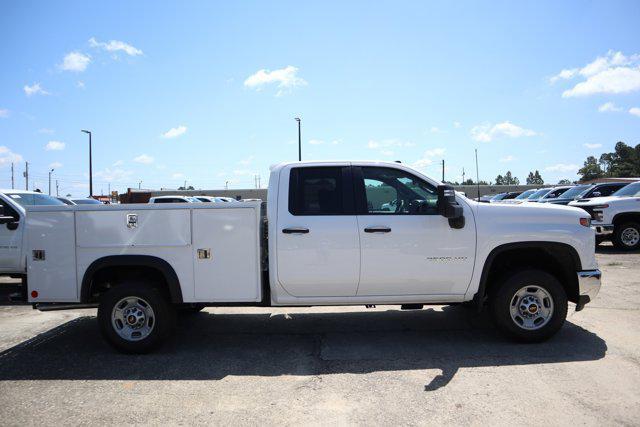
<box><xmin>362</xmin><ymin>167</ymin><xmax>438</xmax><ymax>215</ymax></box>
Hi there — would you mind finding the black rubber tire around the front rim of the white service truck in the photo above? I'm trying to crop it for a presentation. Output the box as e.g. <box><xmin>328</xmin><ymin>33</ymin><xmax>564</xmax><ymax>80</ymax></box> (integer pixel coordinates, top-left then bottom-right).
<box><xmin>490</xmin><ymin>270</ymin><xmax>567</xmax><ymax>342</ymax></box>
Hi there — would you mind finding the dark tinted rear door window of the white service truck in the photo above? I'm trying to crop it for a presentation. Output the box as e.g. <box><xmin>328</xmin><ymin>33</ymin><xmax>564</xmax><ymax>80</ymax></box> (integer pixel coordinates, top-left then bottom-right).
<box><xmin>289</xmin><ymin>167</ymin><xmax>348</xmax><ymax>215</ymax></box>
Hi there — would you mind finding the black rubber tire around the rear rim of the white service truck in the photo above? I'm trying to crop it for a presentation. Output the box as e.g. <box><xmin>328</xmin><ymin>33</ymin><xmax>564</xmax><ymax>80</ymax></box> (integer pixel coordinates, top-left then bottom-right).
<box><xmin>98</xmin><ymin>282</ymin><xmax>176</xmax><ymax>354</ymax></box>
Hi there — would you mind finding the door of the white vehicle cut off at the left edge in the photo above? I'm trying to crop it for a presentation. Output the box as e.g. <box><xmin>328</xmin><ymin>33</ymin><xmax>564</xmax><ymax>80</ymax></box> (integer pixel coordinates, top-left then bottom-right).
<box><xmin>0</xmin><ymin>198</ymin><xmax>24</xmax><ymax>273</ymax></box>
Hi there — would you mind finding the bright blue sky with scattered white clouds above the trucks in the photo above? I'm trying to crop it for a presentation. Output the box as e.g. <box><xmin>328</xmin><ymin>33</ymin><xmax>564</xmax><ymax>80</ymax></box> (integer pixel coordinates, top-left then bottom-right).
<box><xmin>0</xmin><ymin>1</ymin><xmax>640</xmax><ymax>196</ymax></box>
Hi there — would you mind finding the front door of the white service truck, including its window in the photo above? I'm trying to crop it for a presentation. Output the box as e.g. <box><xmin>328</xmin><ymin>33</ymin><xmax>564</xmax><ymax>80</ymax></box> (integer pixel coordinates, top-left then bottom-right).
<box><xmin>353</xmin><ymin>167</ymin><xmax>476</xmax><ymax>296</ymax></box>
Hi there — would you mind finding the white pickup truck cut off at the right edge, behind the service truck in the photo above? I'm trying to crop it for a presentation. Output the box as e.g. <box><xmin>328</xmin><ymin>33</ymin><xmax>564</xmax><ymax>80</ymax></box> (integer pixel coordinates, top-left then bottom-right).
<box><xmin>569</xmin><ymin>182</ymin><xmax>640</xmax><ymax>251</ymax></box>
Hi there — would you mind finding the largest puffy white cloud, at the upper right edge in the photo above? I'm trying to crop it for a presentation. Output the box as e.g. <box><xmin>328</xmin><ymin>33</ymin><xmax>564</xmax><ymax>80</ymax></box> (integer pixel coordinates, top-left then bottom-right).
<box><xmin>550</xmin><ymin>50</ymin><xmax>640</xmax><ymax>98</ymax></box>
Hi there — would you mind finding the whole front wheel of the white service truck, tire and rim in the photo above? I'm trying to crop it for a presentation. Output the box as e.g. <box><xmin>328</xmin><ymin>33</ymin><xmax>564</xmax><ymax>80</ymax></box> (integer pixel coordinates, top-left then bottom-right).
<box><xmin>491</xmin><ymin>270</ymin><xmax>567</xmax><ymax>342</ymax></box>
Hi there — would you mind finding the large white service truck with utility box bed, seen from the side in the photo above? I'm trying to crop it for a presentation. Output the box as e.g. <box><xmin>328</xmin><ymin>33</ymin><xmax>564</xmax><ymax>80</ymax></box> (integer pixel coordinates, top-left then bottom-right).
<box><xmin>17</xmin><ymin>162</ymin><xmax>601</xmax><ymax>352</ymax></box>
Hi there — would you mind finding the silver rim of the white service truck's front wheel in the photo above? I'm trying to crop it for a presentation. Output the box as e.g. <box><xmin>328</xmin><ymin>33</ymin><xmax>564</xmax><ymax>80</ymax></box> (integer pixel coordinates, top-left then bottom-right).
<box><xmin>509</xmin><ymin>285</ymin><xmax>553</xmax><ymax>331</ymax></box>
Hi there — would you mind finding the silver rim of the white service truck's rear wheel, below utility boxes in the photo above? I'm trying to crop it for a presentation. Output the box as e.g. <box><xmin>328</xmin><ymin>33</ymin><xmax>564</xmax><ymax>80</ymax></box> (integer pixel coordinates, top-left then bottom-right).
<box><xmin>111</xmin><ymin>296</ymin><xmax>156</xmax><ymax>341</ymax></box>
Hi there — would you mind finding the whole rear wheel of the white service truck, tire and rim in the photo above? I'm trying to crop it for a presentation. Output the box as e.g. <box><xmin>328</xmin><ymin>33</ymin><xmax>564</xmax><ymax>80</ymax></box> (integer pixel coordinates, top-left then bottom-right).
<box><xmin>98</xmin><ymin>282</ymin><xmax>175</xmax><ymax>353</ymax></box>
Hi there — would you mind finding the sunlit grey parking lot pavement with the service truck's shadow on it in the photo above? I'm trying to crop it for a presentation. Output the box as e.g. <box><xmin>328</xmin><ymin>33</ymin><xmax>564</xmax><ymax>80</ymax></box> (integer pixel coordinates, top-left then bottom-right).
<box><xmin>0</xmin><ymin>246</ymin><xmax>640</xmax><ymax>425</ymax></box>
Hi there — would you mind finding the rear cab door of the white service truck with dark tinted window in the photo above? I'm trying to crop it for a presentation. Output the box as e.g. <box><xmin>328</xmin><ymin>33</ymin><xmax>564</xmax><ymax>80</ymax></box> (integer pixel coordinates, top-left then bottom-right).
<box><xmin>270</xmin><ymin>163</ymin><xmax>360</xmax><ymax>297</ymax></box>
